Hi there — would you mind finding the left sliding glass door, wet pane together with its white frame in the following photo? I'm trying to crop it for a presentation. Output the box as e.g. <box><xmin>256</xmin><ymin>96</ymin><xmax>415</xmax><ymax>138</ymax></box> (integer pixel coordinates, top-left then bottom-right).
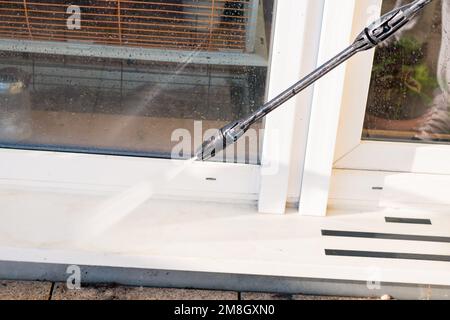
<box><xmin>0</xmin><ymin>0</ymin><xmax>322</xmax><ymax>212</ymax></box>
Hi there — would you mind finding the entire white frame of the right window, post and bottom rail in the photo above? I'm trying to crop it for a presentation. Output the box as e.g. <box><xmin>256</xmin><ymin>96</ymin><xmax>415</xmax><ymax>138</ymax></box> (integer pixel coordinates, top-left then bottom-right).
<box><xmin>300</xmin><ymin>0</ymin><xmax>450</xmax><ymax>216</ymax></box>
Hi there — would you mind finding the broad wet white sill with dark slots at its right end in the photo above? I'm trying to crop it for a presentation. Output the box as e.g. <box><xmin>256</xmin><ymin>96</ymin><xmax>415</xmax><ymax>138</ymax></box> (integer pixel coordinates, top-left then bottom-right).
<box><xmin>0</xmin><ymin>184</ymin><xmax>450</xmax><ymax>285</ymax></box>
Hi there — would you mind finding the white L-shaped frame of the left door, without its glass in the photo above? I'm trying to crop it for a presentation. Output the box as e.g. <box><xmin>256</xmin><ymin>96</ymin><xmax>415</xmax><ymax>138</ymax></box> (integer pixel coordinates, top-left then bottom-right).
<box><xmin>0</xmin><ymin>0</ymin><xmax>322</xmax><ymax>213</ymax></box>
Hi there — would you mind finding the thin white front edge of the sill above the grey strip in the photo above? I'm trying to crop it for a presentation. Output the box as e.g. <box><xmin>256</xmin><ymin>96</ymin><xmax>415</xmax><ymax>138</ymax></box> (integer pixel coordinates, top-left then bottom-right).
<box><xmin>0</xmin><ymin>248</ymin><xmax>450</xmax><ymax>286</ymax></box>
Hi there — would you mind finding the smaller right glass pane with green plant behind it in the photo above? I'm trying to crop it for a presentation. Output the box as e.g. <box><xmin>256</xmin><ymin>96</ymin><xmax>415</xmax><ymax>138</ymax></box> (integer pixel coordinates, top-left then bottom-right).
<box><xmin>363</xmin><ymin>0</ymin><xmax>450</xmax><ymax>143</ymax></box>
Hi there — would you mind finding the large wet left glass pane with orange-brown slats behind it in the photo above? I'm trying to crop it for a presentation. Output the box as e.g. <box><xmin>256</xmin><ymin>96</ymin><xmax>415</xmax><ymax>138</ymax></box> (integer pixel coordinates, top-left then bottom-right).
<box><xmin>0</xmin><ymin>0</ymin><xmax>274</xmax><ymax>163</ymax></box>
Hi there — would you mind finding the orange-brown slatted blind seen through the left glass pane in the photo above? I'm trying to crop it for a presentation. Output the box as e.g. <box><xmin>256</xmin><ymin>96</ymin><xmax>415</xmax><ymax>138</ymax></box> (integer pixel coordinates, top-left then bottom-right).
<box><xmin>0</xmin><ymin>0</ymin><xmax>255</xmax><ymax>52</ymax></box>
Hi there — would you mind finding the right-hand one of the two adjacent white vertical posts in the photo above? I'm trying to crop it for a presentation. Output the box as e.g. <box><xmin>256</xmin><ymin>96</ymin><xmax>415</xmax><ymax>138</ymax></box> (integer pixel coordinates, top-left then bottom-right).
<box><xmin>299</xmin><ymin>0</ymin><xmax>359</xmax><ymax>216</ymax></box>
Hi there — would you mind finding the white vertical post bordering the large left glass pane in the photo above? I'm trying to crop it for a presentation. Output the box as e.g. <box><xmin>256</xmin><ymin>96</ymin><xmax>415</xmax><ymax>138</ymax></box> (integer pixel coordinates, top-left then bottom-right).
<box><xmin>259</xmin><ymin>0</ymin><xmax>323</xmax><ymax>214</ymax></box>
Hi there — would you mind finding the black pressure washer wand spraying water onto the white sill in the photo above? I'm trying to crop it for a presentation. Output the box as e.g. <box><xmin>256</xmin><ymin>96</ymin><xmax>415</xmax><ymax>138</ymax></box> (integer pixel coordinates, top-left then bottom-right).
<box><xmin>194</xmin><ymin>0</ymin><xmax>433</xmax><ymax>161</ymax></box>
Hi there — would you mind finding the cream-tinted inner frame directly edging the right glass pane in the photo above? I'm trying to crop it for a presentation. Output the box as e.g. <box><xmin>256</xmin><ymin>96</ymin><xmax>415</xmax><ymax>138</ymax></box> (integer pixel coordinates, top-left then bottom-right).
<box><xmin>335</xmin><ymin>0</ymin><xmax>450</xmax><ymax>174</ymax></box>
